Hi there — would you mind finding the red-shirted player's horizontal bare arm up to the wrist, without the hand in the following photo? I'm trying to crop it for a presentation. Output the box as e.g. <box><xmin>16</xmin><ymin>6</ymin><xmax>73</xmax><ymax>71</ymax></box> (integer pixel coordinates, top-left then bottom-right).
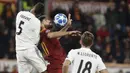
<box><xmin>47</xmin><ymin>31</ymin><xmax>69</xmax><ymax>38</ymax></box>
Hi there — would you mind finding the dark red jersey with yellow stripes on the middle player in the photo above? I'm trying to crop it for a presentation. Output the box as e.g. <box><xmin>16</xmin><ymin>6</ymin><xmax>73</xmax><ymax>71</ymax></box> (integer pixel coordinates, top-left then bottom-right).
<box><xmin>40</xmin><ymin>29</ymin><xmax>66</xmax><ymax>68</ymax></box>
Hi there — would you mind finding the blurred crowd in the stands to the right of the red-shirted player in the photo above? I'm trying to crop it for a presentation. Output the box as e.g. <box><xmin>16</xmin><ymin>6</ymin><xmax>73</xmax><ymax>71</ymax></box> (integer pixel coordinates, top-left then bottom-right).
<box><xmin>50</xmin><ymin>0</ymin><xmax>130</xmax><ymax>63</ymax></box>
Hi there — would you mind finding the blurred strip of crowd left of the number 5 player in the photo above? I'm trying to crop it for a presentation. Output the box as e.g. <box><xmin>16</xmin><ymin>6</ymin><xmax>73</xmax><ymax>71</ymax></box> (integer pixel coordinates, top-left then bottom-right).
<box><xmin>0</xmin><ymin>3</ymin><xmax>16</xmax><ymax>59</ymax></box>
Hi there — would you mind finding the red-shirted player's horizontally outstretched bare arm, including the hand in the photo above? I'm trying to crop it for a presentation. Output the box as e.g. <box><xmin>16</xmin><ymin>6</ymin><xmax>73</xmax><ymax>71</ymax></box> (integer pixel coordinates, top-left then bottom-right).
<box><xmin>47</xmin><ymin>31</ymin><xmax>81</xmax><ymax>38</ymax></box>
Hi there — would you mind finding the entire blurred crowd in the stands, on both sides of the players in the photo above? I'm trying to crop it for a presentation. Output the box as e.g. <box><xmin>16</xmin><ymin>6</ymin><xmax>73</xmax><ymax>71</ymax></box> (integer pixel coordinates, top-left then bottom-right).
<box><xmin>0</xmin><ymin>0</ymin><xmax>130</xmax><ymax>63</ymax></box>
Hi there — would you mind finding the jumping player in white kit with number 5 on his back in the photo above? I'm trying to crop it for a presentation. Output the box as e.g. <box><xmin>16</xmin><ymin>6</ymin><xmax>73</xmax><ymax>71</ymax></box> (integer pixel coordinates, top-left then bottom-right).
<box><xmin>15</xmin><ymin>3</ymin><xmax>46</xmax><ymax>73</ymax></box>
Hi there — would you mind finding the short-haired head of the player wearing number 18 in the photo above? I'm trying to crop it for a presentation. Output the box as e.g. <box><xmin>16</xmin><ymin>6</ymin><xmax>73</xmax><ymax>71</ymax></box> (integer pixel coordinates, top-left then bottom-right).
<box><xmin>80</xmin><ymin>31</ymin><xmax>94</xmax><ymax>47</ymax></box>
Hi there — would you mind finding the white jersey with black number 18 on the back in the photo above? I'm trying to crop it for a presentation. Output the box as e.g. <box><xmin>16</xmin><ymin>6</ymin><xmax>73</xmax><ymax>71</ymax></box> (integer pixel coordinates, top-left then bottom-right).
<box><xmin>66</xmin><ymin>48</ymin><xmax>106</xmax><ymax>73</ymax></box>
